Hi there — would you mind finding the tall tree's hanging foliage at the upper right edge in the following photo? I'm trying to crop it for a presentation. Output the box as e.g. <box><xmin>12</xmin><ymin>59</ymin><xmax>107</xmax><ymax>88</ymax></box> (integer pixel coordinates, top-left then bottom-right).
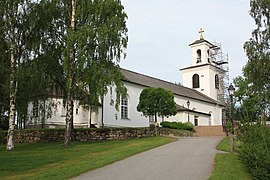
<box><xmin>243</xmin><ymin>0</ymin><xmax>270</xmax><ymax>118</ymax></box>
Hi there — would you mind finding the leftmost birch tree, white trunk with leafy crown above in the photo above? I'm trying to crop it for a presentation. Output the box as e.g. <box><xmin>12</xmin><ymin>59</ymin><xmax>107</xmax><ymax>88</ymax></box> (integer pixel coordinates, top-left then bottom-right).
<box><xmin>0</xmin><ymin>0</ymin><xmax>39</xmax><ymax>150</ymax></box>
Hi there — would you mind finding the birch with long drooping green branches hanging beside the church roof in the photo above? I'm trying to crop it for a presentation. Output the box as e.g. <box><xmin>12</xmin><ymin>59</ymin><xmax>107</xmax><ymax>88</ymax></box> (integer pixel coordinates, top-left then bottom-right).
<box><xmin>64</xmin><ymin>0</ymin><xmax>127</xmax><ymax>145</ymax></box>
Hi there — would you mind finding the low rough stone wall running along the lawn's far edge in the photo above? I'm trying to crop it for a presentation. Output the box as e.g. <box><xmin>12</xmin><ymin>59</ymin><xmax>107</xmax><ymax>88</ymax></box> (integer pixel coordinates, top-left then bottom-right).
<box><xmin>0</xmin><ymin>127</ymin><xmax>196</xmax><ymax>143</ymax></box>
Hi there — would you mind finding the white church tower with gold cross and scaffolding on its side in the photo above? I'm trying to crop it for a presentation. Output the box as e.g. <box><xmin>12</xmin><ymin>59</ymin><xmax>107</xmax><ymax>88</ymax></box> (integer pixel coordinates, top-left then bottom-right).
<box><xmin>180</xmin><ymin>28</ymin><xmax>228</xmax><ymax>103</ymax></box>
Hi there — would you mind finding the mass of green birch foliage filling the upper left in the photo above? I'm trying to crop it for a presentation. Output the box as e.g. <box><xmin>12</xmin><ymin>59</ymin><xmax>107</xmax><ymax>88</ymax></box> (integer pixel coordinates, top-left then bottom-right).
<box><xmin>0</xmin><ymin>0</ymin><xmax>128</xmax><ymax>146</ymax></box>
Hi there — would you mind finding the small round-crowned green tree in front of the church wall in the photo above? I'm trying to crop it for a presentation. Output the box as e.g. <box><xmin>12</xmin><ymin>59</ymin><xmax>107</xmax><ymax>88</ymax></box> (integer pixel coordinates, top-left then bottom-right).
<box><xmin>137</xmin><ymin>88</ymin><xmax>177</xmax><ymax>122</ymax></box>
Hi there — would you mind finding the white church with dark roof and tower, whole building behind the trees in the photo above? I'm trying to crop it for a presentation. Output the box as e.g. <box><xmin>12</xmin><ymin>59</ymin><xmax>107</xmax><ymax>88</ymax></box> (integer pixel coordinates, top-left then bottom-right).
<box><xmin>27</xmin><ymin>32</ymin><xmax>225</xmax><ymax>128</ymax></box>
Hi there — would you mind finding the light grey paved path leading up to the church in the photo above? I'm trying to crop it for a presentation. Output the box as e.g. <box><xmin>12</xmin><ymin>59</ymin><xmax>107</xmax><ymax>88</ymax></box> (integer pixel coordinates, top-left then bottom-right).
<box><xmin>71</xmin><ymin>137</ymin><xmax>222</xmax><ymax>180</ymax></box>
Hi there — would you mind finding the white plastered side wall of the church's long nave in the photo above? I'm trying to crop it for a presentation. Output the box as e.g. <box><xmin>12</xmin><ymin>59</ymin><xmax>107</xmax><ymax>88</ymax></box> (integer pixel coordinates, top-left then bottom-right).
<box><xmin>104</xmin><ymin>82</ymin><xmax>222</xmax><ymax>127</ymax></box>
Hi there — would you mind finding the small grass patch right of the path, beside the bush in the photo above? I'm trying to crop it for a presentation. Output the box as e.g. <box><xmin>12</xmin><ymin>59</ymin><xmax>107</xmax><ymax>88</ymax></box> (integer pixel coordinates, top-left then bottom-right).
<box><xmin>209</xmin><ymin>137</ymin><xmax>252</xmax><ymax>180</ymax></box>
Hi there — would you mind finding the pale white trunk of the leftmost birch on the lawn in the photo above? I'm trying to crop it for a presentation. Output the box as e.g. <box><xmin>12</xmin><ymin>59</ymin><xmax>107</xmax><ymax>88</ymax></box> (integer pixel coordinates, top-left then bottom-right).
<box><xmin>6</xmin><ymin>47</ymin><xmax>17</xmax><ymax>151</ymax></box>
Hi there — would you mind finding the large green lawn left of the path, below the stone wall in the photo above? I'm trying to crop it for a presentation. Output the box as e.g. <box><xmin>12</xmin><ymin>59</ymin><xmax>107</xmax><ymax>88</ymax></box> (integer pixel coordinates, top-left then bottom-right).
<box><xmin>0</xmin><ymin>137</ymin><xmax>174</xmax><ymax>179</ymax></box>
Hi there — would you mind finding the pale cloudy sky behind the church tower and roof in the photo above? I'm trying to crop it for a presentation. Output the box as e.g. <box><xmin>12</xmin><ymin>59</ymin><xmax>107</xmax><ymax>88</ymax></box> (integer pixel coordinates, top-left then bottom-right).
<box><xmin>120</xmin><ymin>0</ymin><xmax>255</xmax><ymax>83</ymax></box>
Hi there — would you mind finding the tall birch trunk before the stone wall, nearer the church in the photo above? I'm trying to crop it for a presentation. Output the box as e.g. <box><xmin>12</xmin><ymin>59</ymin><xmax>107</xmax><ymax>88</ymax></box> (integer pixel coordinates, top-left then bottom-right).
<box><xmin>64</xmin><ymin>0</ymin><xmax>76</xmax><ymax>146</ymax></box>
